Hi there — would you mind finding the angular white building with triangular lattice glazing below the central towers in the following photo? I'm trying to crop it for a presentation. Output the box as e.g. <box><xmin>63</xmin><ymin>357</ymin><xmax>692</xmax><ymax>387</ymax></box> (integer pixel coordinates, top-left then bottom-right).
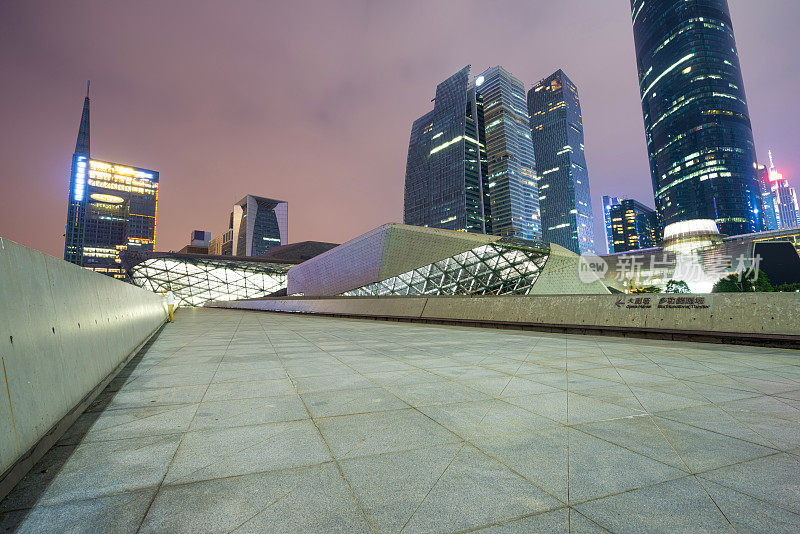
<box><xmin>287</xmin><ymin>223</ymin><xmax>608</xmax><ymax>296</ymax></box>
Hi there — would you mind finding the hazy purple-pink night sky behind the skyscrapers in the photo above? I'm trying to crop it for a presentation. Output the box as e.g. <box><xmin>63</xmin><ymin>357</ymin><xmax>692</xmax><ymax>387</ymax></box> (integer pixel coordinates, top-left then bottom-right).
<box><xmin>0</xmin><ymin>0</ymin><xmax>800</xmax><ymax>257</ymax></box>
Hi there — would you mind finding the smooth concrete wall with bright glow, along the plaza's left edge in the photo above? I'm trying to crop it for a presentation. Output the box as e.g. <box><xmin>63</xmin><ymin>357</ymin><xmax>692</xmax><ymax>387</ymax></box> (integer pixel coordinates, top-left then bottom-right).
<box><xmin>0</xmin><ymin>238</ymin><xmax>166</xmax><ymax>498</ymax></box>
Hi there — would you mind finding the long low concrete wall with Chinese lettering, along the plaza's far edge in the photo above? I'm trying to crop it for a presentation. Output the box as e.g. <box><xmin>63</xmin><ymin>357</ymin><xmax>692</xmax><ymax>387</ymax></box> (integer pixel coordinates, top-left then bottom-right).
<box><xmin>211</xmin><ymin>293</ymin><xmax>800</xmax><ymax>337</ymax></box>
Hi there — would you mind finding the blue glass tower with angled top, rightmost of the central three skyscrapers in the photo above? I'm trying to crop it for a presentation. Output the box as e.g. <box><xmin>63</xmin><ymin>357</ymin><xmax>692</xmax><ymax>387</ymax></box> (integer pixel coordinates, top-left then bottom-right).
<box><xmin>528</xmin><ymin>69</ymin><xmax>594</xmax><ymax>254</ymax></box>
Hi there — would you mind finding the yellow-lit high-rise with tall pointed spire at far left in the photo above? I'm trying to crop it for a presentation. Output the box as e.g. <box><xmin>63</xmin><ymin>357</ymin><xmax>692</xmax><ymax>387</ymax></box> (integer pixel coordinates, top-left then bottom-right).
<box><xmin>64</xmin><ymin>86</ymin><xmax>158</xmax><ymax>278</ymax></box>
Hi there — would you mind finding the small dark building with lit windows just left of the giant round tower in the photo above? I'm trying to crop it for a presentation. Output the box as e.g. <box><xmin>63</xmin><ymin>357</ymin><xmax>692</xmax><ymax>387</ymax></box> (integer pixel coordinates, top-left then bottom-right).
<box><xmin>603</xmin><ymin>197</ymin><xmax>663</xmax><ymax>253</ymax></box>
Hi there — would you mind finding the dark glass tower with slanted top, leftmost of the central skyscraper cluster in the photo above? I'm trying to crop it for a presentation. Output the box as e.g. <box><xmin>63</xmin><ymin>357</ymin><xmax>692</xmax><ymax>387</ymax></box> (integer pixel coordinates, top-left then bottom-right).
<box><xmin>403</xmin><ymin>66</ymin><xmax>492</xmax><ymax>233</ymax></box>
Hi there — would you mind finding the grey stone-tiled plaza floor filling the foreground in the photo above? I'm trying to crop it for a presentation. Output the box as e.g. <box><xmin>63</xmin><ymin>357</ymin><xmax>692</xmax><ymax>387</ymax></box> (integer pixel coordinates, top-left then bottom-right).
<box><xmin>0</xmin><ymin>309</ymin><xmax>800</xmax><ymax>533</ymax></box>
